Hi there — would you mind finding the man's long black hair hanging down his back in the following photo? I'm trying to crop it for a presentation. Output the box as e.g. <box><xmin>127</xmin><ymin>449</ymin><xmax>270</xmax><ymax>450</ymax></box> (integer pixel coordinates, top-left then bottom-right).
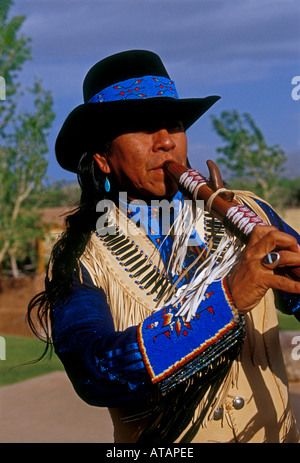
<box><xmin>26</xmin><ymin>147</ymin><xmax>114</xmax><ymax>358</ymax></box>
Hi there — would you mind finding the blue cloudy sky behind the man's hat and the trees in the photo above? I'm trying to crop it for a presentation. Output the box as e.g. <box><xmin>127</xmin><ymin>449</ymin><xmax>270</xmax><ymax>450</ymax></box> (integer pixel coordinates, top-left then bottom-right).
<box><xmin>11</xmin><ymin>0</ymin><xmax>300</xmax><ymax>180</ymax></box>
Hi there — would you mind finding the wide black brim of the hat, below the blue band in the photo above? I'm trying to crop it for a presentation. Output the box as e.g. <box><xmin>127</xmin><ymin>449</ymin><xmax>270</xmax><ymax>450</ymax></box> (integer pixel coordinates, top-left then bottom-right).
<box><xmin>55</xmin><ymin>95</ymin><xmax>220</xmax><ymax>173</ymax></box>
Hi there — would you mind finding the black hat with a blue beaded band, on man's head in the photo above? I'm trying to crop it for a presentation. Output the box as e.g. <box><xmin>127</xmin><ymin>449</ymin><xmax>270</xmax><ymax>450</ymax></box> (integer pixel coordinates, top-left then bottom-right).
<box><xmin>55</xmin><ymin>50</ymin><xmax>220</xmax><ymax>172</ymax></box>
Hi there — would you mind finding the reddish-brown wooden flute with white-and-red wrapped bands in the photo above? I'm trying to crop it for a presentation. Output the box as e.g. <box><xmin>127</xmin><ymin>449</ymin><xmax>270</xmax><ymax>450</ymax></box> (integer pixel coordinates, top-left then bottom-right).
<box><xmin>163</xmin><ymin>161</ymin><xmax>300</xmax><ymax>281</ymax></box>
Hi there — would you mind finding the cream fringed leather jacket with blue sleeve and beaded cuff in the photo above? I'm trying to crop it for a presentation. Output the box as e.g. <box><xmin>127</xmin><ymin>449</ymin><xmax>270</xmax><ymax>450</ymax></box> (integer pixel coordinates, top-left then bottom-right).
<box><xmin>52</xmin><ymin>191</ymin><xmax>299</xmax><ymax>443</ymax></box>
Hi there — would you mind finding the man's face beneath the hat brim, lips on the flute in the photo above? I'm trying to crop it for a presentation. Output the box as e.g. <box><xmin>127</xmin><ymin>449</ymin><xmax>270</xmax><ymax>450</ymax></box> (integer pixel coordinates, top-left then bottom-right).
<box><xmin>95</xmin><ymin>121</ymin><xmax>187</xmax><ymax>199</ymax></box>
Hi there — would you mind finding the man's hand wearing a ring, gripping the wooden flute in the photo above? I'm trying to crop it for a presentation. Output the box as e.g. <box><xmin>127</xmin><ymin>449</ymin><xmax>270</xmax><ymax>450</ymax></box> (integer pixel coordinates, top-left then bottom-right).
<box><xmin>228</xmin><ymin>226</ymin><xmax>300</xmax><ymax>313</ymax></box>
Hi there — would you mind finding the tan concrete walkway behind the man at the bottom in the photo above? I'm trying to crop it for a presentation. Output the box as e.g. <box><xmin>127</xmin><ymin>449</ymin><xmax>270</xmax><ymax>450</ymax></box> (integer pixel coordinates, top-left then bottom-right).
<box><xmin>0</xmin><ymin>372</ymin><xmax>300</xmax><ymax>443</ymax></box>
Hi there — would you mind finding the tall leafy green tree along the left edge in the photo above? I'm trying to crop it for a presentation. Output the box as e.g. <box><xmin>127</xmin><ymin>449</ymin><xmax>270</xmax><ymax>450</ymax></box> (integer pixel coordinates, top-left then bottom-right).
<box><xmin>0</xmin><ymin>0</ymin><xmax>54</xmax><ymax>276</ymax></box>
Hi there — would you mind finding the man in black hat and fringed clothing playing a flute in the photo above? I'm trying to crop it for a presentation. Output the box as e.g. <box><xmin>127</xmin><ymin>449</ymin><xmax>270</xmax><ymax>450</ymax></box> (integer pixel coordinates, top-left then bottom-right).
<box><xmin>29</xmin><ymin>50</ymin><xmax>300</xmax><ymax>443</ymax></box>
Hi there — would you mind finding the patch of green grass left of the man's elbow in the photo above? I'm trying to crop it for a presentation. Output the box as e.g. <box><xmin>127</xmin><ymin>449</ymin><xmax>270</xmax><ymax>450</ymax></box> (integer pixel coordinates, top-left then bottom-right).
<box><xmin>0</xmin><ymin>335</ymin><xmax>63</xmax><ymax>386</ymax></box>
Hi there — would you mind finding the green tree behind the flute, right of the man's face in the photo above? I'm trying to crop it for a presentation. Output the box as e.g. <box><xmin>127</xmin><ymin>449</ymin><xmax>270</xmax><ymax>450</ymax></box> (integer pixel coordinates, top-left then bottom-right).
<box><xmin>212</xmin><ymin>110</ymin><xmax>286</xmax><ymax>203</ymax></box>
